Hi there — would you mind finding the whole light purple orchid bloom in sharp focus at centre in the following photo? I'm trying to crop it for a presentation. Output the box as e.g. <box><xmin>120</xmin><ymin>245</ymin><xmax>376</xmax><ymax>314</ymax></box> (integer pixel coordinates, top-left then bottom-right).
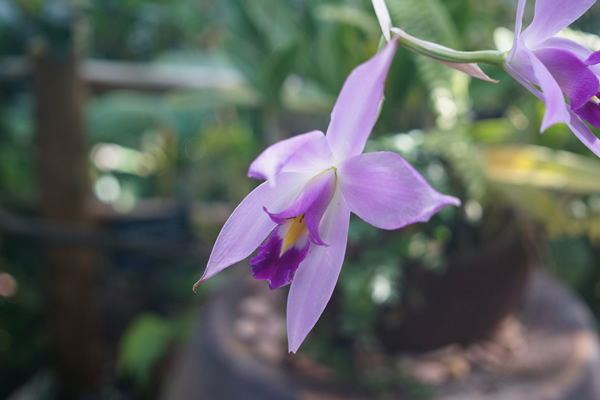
<box><xmin>194</xmin><ymin>41</ymin><xmax>460</xmax><ymax>352</ymax></box>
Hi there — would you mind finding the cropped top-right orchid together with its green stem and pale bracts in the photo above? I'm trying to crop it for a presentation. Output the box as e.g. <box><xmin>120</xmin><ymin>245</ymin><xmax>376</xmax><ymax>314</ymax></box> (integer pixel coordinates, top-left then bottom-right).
<box><xmin>372</xmin><ymin>0</ymin><xmax>600</xmax><ymax>157</ymax></box>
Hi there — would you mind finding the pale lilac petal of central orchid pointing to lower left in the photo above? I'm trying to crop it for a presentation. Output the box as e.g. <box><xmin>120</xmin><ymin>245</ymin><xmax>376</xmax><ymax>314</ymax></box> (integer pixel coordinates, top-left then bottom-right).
<box><xmin>194</xmin><ymin>172</ymin><xmax>311</xmax><ymax>290</ymax></box>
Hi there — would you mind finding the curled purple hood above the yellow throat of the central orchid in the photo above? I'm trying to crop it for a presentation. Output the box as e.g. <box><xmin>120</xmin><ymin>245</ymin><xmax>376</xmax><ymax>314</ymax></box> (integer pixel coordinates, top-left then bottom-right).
<box><xmin>265</xmin><ymin>168</ymin><xmax>337</xmax><ymax>246</ymax></box>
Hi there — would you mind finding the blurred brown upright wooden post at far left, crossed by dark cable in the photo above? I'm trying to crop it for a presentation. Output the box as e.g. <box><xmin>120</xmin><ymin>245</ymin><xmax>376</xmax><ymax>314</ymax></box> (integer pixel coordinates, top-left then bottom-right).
<box><xmin>32</xmin><ymin>48</ymin><xmax>101</xmax><ymax>399</ymax></box>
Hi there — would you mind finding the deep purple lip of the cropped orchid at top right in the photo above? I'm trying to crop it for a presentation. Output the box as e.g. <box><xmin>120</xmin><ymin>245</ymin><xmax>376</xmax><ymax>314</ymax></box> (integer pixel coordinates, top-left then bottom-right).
<box><xmin>533</xmin><ymin>47</ymin><xmax>600</xmax><ymax>110</ymax></box>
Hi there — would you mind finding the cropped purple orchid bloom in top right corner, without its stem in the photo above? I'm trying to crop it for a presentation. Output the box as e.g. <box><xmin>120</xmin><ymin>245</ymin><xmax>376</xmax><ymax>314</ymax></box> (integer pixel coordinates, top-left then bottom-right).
<box><xmin>505</xmin><ymin>0</ymin><xmax>600</xmax><ymax>157</ymax></box>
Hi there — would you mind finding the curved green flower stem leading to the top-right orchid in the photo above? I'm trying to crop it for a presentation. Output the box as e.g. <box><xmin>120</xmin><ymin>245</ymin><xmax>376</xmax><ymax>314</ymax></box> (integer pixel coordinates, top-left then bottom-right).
<box><xmin>391</xmin><ymin>28</ymin><xmax>507</xmax><ymax>68</ymax></box>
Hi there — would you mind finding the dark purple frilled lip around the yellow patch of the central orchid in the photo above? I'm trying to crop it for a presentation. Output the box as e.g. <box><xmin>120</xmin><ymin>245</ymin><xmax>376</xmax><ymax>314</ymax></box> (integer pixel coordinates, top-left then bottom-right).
<box><xmin>250</xmin><ymin>221</ymin><xmax>310</xmax><ymax>290</ymax></box>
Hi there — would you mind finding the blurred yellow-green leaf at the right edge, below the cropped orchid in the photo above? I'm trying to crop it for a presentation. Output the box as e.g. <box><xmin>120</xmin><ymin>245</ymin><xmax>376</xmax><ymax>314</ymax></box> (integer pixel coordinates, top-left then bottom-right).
<box><xmin>482</xmin><ymin>145</ymin><xmax>600</xmax><ymax>242</ymax></box>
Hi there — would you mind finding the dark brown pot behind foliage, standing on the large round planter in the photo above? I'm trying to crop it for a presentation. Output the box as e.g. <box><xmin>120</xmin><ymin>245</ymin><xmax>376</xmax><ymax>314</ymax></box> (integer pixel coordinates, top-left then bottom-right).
<box><xmin>378</xmin><ymin>226</ymin><xmax>539</xmax><ymax>351</ymax></box>
